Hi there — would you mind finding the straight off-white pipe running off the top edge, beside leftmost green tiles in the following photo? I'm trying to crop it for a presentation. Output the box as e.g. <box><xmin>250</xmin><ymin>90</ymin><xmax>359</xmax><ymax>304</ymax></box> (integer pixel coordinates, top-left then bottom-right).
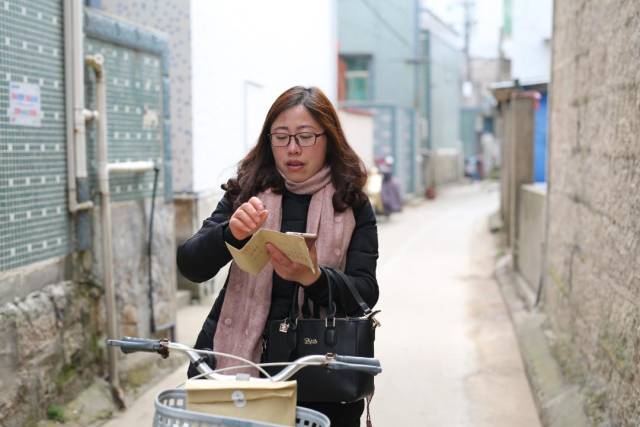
<box><xmin>64</xmin><ymin>0</ymin><xmax>93</xmax><ymax>213</ymax></box>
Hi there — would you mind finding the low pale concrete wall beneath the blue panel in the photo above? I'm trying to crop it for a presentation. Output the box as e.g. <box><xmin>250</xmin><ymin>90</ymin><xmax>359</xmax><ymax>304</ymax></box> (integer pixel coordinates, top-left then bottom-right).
<box><xmin>515</xmin><ymin>184</ymin><xmax>547</xmax><ymax>293</ymax></box>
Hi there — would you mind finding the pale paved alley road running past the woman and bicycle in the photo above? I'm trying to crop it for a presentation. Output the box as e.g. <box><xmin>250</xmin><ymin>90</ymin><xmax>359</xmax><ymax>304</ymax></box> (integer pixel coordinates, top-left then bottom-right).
<box><xmin>106</xmin><ymin>184</ymin><xmax>540</xmax><ymax>427</ymax></box>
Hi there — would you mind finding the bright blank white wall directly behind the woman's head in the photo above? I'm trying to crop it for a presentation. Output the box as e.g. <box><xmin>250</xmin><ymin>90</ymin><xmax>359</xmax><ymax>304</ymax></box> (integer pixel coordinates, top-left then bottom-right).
<box><xmin>191</xmin><ymin>0</ymin><xmax>337</xmax><ymax>192</ymax></box>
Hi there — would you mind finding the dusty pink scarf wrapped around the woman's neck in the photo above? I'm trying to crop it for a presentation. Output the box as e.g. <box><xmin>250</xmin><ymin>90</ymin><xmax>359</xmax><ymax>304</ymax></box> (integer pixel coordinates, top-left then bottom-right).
<box><xmin>213</xmin><ymin>167</ymin><xmax>355</xmax><ymax>376</ymax></box>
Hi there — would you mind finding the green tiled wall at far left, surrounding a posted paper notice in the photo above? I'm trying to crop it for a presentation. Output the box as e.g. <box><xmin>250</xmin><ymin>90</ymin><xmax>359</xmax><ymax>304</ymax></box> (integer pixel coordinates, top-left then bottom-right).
<box><xmin>0</xmin><ymin>0</ymin><xmax>70</xmax><ymax>271</ymax></box>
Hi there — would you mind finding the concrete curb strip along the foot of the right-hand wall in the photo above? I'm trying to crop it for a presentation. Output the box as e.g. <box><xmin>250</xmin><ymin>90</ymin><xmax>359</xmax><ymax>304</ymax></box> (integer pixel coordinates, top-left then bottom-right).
<box><xmin>494</xmin><ymin>255</ymin><xmax>591</xmax><ymax>427</ymax></box>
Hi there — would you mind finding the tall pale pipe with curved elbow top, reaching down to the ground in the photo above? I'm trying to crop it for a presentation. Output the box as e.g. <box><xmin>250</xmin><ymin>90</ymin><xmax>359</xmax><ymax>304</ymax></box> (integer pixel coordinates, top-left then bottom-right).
<box><xmin>85</xmin><ymin>54</ymin><xmax>119</xmax><ymax>389</ymax></box>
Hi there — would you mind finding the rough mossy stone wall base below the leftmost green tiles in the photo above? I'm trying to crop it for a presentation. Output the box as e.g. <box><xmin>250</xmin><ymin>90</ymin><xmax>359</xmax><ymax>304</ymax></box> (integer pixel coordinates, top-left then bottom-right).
<box><xmin>0</xmin><ymin>281</ymin><xmax>104</xmax><ymax>427</ymax></box>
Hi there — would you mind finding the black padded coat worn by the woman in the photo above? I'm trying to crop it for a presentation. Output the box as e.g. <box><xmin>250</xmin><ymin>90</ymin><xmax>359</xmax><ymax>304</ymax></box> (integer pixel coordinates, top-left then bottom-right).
<box><xmin>177</xmin><ymin>190</ymin><xmax>378</xmax><ymax>332</ymax></box>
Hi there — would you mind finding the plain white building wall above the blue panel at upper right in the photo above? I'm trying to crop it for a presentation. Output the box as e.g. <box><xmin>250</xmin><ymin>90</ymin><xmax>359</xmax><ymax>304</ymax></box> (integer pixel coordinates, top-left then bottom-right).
<box><xmin>509</xmin><ymin>0</ymin><xmax>553</xmax><ymax>82</ymax></box>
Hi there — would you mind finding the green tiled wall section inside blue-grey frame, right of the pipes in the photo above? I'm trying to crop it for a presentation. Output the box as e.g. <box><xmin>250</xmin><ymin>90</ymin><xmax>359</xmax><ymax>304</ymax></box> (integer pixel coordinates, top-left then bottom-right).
<box><xmin>85</xmin><ymin>38</ymin><xmax>163</xmax><ymax>201</ymax></box>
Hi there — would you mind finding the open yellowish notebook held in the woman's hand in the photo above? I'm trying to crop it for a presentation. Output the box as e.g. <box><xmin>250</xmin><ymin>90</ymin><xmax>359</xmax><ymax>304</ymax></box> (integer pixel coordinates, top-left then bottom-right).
<box><xmin>225</xmin><ymin>229</ymin><xmax>316</xmax><ymax>276</ymax></box>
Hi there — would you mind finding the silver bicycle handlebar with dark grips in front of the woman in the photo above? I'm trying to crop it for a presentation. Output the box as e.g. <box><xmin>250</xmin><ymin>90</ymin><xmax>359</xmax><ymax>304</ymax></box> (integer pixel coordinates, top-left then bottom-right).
<box><xmin>107</xmin><ymin>337</ymin><xmax>382</xmax><ymax>381</ymax></box>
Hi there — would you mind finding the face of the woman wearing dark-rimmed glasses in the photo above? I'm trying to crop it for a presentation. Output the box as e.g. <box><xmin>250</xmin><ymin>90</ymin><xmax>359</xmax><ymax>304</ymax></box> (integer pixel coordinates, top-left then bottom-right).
<box><xmin>270</xmin><ymin>105</ymin><xmax>327</xmax><ymax>182</ymax></box>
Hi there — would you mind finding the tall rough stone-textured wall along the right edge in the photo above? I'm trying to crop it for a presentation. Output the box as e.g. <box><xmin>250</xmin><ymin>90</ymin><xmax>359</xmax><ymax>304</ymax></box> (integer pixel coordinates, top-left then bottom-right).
<box><xmin>545</xmin><ymin>0</ymin><xmax>640</xmax><ymax>426</ymax></box>
